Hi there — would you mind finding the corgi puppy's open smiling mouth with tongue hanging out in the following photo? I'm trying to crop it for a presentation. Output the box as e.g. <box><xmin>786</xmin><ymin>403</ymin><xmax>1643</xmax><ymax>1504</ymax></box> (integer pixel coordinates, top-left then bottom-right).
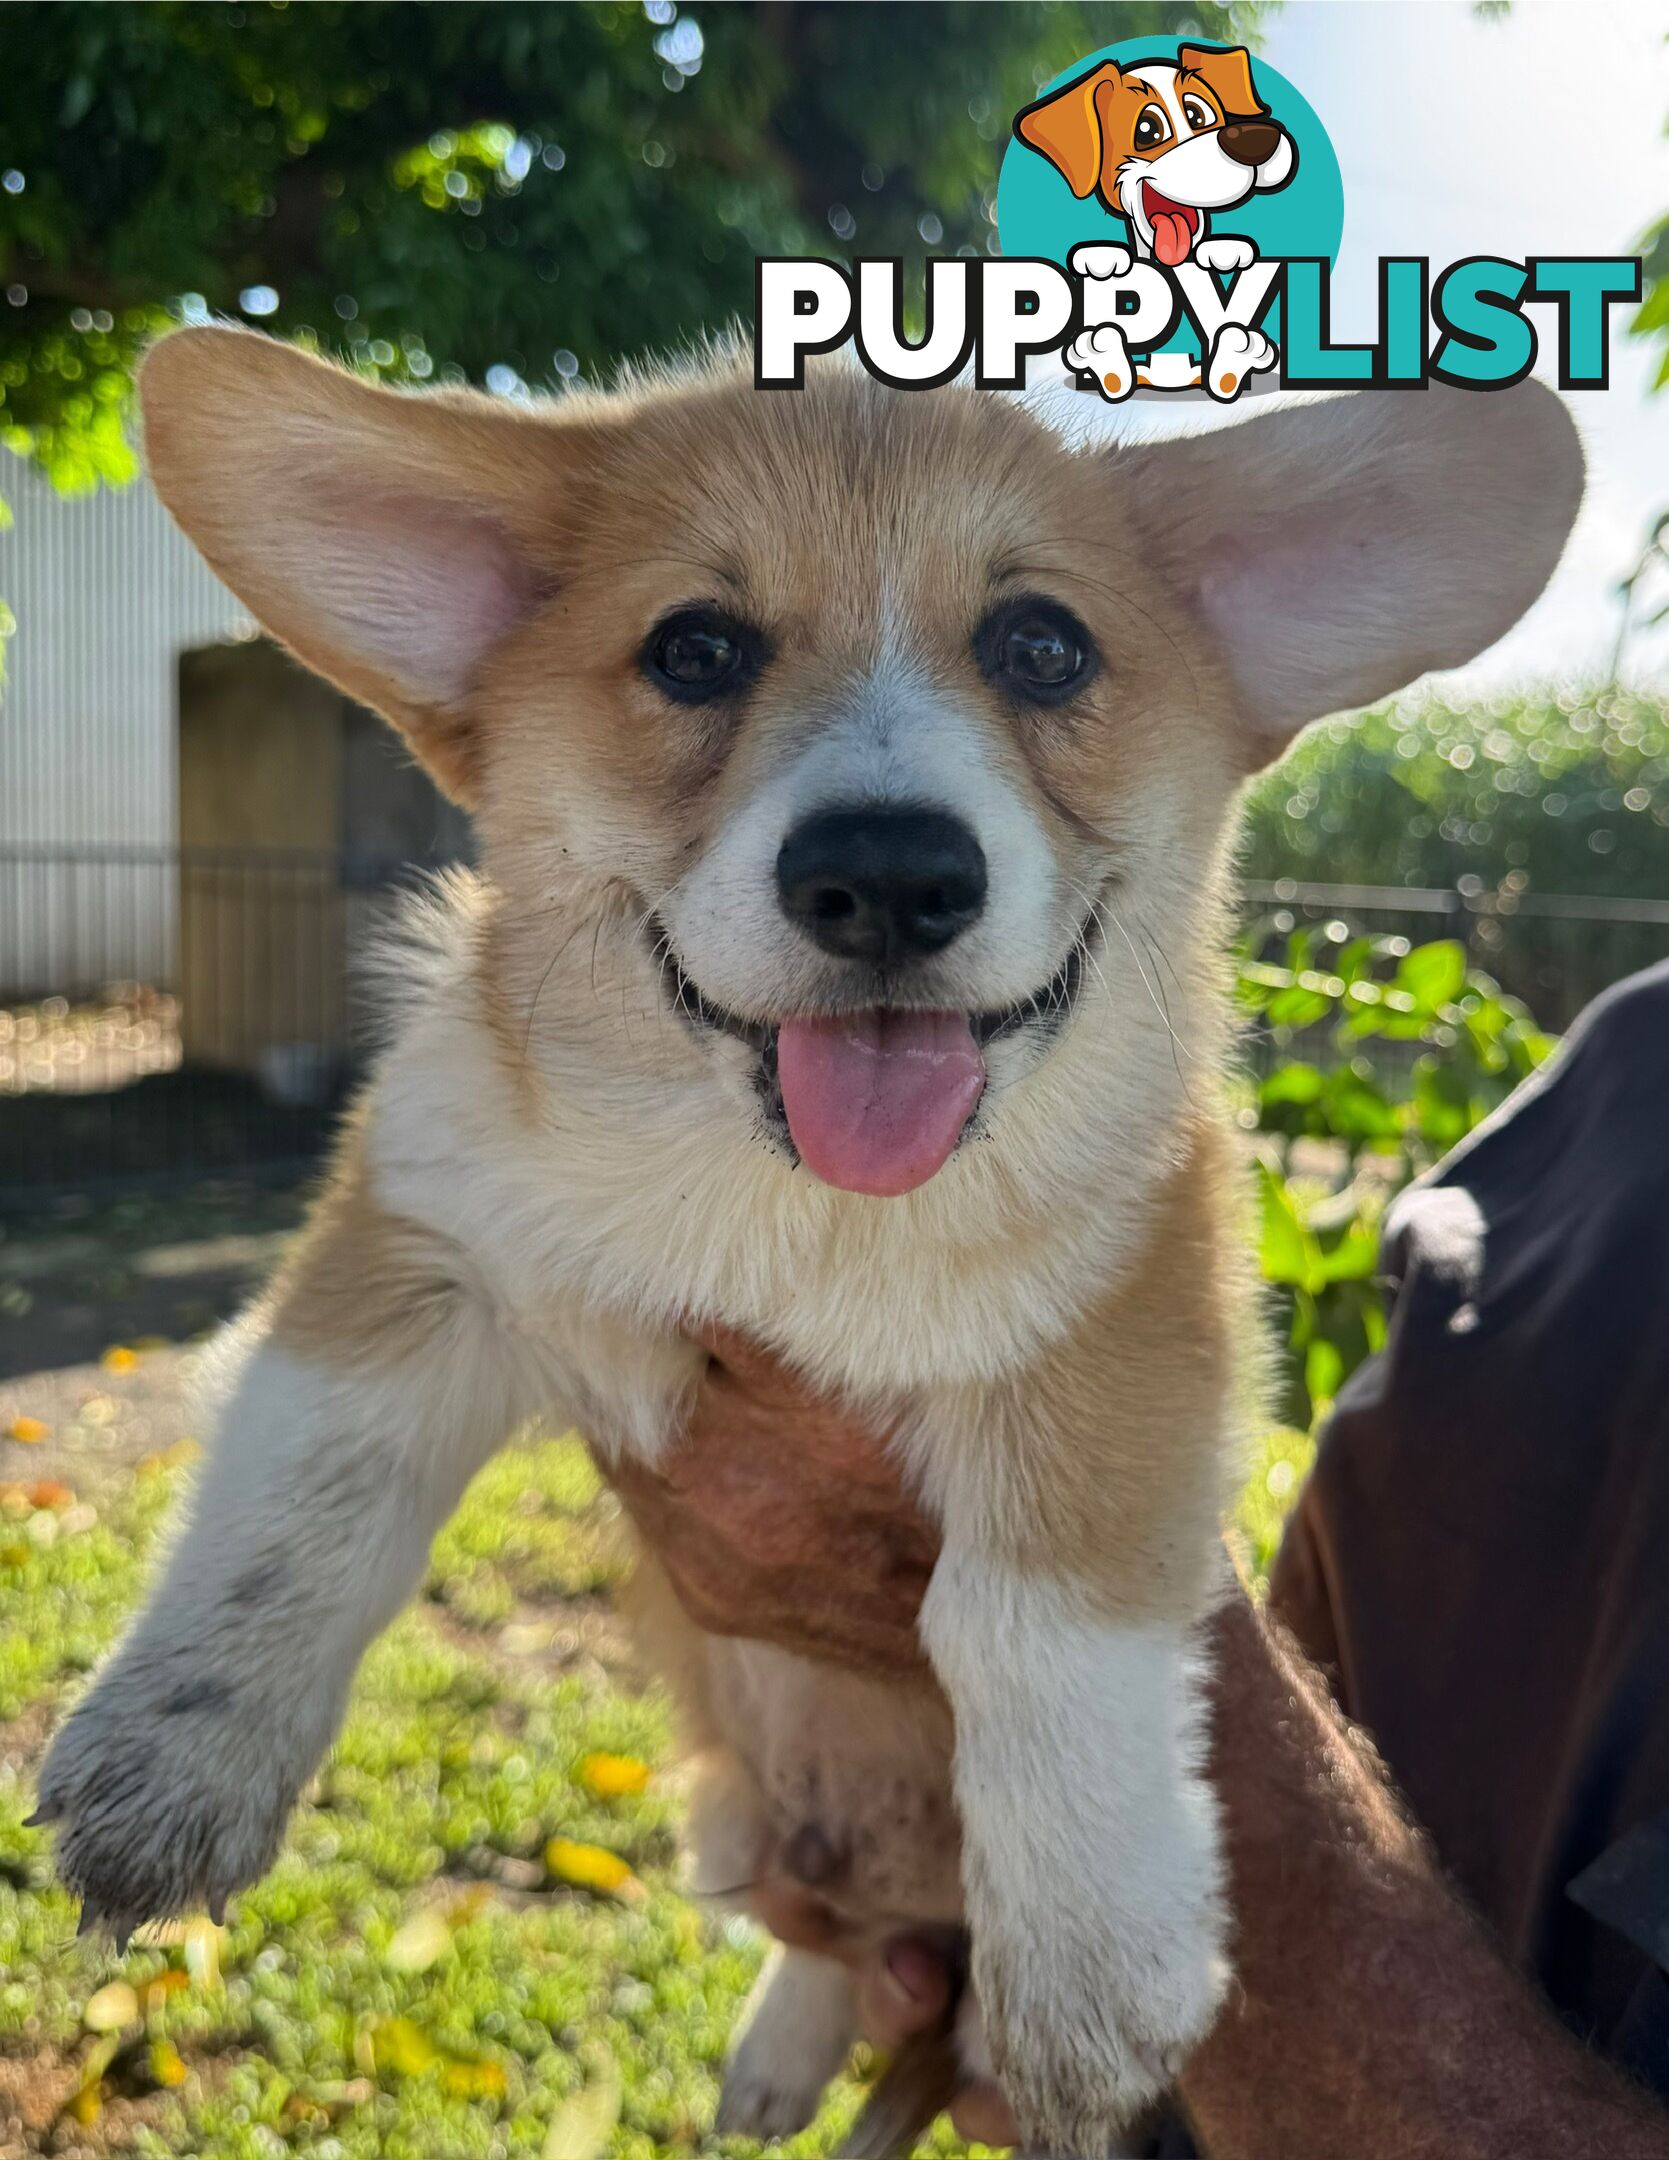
<box><xmin>650</xmin><ymin>912</ymin><xmax>1099</xmax><ymax>1194</ymax></box>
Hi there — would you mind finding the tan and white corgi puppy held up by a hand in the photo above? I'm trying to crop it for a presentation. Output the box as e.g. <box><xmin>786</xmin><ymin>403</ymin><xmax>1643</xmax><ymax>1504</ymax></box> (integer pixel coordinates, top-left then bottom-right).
<box><xmin>41</xmin><ymin>328</ymin><xmax>1580</xmax><ymax>2154</ymax></box>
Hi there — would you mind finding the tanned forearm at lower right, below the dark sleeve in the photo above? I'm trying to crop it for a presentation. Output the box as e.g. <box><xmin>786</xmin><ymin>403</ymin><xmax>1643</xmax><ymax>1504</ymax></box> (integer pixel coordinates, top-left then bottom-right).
<box><xmin>1181</xmin><ymin>1598</ymin><xmax>1669</xmax><ymax>2160</ymax></box>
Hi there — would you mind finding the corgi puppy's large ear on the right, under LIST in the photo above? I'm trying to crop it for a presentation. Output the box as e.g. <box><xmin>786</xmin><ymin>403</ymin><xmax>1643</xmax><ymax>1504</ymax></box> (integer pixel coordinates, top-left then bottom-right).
<box><xmin>1103</xmin><ymin>380</ymin><xmax>1583</xmax><ymax>771</ymax></box>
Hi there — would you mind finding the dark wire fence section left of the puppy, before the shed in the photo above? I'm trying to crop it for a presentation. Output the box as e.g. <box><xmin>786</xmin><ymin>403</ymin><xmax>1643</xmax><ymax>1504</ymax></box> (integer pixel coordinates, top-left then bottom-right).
<box><xmin>0</xmin><ymin>847</ymin><xmax>423</xmax><ymax>1210</ymax></box>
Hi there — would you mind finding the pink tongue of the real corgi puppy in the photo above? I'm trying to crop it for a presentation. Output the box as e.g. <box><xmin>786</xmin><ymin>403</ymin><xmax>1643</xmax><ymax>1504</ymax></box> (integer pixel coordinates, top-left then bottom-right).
<box><xmin>777</xmin><ymin>1011</ymin><xmax>985</xmax><ymax>1194</ymax></box>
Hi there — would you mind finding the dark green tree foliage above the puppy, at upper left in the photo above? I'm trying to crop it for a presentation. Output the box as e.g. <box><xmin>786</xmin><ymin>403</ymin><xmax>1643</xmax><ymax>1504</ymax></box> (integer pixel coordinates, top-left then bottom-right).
<box><xmin>0</xmin><ymin>0</ymin><xmax>1254</xmax><ymax>486</ymax></box>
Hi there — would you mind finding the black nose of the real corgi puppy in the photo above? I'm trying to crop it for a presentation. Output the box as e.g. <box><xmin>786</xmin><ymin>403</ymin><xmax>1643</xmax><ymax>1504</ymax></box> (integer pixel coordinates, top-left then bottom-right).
<box><xmin>777</xmin><ymin>810</ymin><xmax>985</xmax><ymax>968</ymax></box>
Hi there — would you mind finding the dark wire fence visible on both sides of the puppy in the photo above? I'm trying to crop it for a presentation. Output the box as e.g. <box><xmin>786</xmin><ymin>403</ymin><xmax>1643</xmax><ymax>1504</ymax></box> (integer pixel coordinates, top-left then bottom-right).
<box><xmin>0</xmin><ymin>847</ymin><xmax>1669</xmax><ymax>1212</ymax></box>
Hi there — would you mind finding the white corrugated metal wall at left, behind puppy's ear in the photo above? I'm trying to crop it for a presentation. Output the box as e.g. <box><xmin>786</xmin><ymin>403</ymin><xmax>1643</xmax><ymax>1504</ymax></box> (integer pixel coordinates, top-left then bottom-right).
<box><xmin>0</xmin><ymin>456</ymin><xmax>248</xmax><ymax>989</ymax></box>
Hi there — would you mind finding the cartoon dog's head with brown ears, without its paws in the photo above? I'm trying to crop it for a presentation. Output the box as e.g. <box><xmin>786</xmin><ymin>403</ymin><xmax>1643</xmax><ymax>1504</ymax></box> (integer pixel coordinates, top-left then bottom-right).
<box><xmin>1015</xmin><ymin>45</ymin><xmax>1298</xmax><ymax>270</ymax></box>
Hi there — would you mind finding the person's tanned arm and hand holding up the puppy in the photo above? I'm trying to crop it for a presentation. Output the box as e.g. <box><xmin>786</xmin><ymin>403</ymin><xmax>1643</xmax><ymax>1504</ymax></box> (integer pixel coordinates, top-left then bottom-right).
<box><xmin>608</xmin><ymin>1365</ymin><xmax>1669</xmax><ymax>2160</ymax></box>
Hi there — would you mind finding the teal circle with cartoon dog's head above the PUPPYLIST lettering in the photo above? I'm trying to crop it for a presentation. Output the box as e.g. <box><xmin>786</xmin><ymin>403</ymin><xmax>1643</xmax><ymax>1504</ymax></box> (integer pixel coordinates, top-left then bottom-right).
<box><xmin>998</xmin><ymin>37</ymin><xmax>1345</xmax><ymax>268</ymax></box>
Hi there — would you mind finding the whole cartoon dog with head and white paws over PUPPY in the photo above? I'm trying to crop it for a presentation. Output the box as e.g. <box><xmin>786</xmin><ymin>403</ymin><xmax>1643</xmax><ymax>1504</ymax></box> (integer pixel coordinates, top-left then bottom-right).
<box><xmin>1015</xmin><ymin>45</ymin><xmax>1298</xmax><ymax>400</ymax></box>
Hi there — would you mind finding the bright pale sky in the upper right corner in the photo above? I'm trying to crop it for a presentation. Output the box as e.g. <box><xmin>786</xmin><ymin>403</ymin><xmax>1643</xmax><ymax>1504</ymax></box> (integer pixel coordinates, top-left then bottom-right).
<box><xmin>1036</xmin><ymin>0</ymin><xmax>1669</xmax><ymax>683</ymax></box>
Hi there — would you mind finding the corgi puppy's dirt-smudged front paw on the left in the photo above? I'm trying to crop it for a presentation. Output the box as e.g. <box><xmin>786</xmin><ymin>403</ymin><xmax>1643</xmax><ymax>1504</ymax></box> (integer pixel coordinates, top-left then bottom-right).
<box><xmin>37</xmin><ymin>1659</ymin><xmax>313</xmax><ymax>1942</ymax></box>
